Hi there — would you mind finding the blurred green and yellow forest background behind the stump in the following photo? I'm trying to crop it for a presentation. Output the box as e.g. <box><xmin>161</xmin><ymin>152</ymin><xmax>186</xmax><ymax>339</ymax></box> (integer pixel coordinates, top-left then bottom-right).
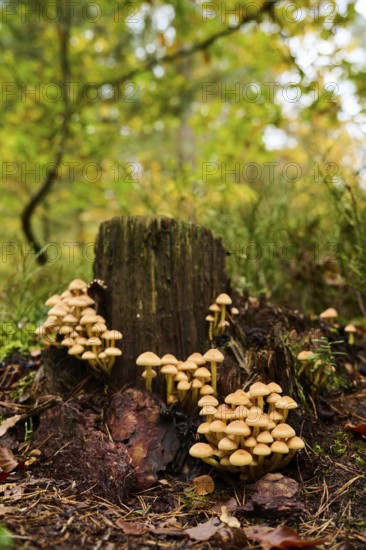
<box><xmin>0</xmin><ymin>0</ymin><xmax>366</xmax><ymax>336</ymax></box>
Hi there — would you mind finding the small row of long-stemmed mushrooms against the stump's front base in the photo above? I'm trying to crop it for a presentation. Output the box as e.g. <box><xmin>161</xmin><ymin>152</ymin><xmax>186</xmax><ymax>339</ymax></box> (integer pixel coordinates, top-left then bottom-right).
<box><xmin>136</xmin><ymin>348</ymin><xmax>224</xmax><ymax>411</ymax></box>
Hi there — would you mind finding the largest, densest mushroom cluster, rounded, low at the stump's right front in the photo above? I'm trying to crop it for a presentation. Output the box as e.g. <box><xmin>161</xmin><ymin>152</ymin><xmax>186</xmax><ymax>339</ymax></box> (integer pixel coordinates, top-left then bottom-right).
<box><xmin>189</xmin><ymin>382</ymin><xmax>305</xmax><ymax>479</ymax></box>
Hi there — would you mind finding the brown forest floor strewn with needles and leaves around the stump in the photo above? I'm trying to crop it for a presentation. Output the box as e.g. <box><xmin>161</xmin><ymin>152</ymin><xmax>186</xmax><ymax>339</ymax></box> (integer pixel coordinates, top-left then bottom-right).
<box><xmin>0</xmin><ymin>304</ymin><xmax>366</xmax><ymax>550</ymax></box>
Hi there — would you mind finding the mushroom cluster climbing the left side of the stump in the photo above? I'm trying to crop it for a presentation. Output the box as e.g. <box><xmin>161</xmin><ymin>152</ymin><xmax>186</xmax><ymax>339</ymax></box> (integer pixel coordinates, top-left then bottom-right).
<box><xmin>35</xmin><ymin>279</ymin><xmax>122</xmax><ymax>374</ymax></box>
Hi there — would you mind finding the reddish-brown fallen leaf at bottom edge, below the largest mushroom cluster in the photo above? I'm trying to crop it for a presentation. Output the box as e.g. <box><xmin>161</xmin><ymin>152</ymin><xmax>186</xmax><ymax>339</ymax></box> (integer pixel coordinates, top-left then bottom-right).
<box><xmin>244</xmin><ymin>525</ymin><xmax>326</xmax><ymax>550</ymax></box>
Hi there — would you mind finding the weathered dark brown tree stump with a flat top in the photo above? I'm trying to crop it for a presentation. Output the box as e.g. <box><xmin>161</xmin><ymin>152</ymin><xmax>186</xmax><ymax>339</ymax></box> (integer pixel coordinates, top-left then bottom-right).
<box><xmin>94</xmin><ymin>216</ymin><xmax>228</xmax><ymax>384</ymax></box>
